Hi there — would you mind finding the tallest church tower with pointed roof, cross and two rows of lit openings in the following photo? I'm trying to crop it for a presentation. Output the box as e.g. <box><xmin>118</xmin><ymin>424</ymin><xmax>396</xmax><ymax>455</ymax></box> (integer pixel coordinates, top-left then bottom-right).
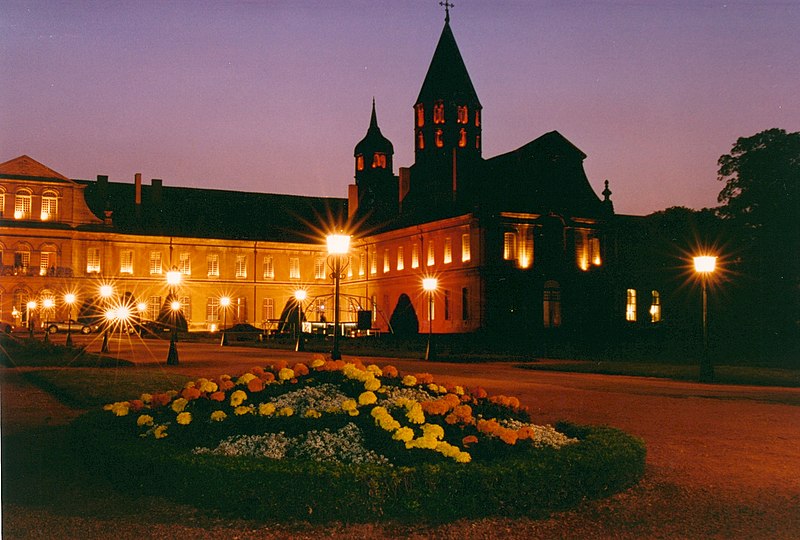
<box><xmin>411</xmin><ymin>9</ymin><xmax>482</xmax><ymax>210</ymax></box>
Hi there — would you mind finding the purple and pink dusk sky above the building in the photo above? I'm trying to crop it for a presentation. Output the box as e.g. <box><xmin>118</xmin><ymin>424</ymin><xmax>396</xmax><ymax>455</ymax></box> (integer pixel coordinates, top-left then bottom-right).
<box><xmin>0</xmin><ymin>0</ymin><xmax>800</xmax><ymax>214</ymax></box>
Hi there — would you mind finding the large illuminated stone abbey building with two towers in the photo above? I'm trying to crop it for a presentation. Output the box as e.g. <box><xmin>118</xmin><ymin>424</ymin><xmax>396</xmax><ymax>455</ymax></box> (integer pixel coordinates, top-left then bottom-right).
<box><xmin>0</xmin><ymin>13</ymin><xmax>660</xmax><ymax>337</ymax></box>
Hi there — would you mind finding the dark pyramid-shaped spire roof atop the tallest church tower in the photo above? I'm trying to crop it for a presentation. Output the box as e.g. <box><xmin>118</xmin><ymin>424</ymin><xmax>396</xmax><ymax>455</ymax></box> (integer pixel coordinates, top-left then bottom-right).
<box><xmin>416</xmin><ymin>20</ymin><xmax>480</xmax><ymax>106</ymax></box>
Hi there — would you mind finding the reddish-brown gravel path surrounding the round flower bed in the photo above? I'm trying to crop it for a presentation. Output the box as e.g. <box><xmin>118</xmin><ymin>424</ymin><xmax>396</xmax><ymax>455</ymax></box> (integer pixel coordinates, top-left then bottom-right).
<box><xmin>0</xmin><ymin>344</ymin><xmax>800</xmax><ymax>540</ymax></box>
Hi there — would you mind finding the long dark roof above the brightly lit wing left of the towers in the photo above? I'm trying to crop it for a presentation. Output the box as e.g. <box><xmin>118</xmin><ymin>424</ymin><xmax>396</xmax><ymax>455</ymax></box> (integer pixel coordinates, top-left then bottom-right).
<box><xmin>79</xmin><ymin>180</ymin><xmax>347</xmax><ymax>243</ymax></box>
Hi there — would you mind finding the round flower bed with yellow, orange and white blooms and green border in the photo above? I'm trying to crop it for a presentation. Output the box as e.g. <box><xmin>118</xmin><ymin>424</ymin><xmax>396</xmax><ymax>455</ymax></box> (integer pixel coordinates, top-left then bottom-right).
<box><xmin>75</xmin><ymin>357</ymin><xmax>645</xmax><ymax>521</ymax></box>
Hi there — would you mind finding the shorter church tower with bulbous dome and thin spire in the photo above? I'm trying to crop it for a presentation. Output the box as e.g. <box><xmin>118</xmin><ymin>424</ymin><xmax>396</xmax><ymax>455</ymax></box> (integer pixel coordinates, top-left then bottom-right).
<box><xmin>353</xmin><ymin>98</ymin><xmax>398</xmax><ymax>221</ymax></box>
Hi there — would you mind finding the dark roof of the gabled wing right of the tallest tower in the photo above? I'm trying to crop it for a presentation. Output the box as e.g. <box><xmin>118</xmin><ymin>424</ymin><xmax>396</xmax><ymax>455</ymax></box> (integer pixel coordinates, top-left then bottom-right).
<box><xmin>484</xmin><ymin>131</ymin><xmax>605</xmax><ymax>218</ymax></box>
